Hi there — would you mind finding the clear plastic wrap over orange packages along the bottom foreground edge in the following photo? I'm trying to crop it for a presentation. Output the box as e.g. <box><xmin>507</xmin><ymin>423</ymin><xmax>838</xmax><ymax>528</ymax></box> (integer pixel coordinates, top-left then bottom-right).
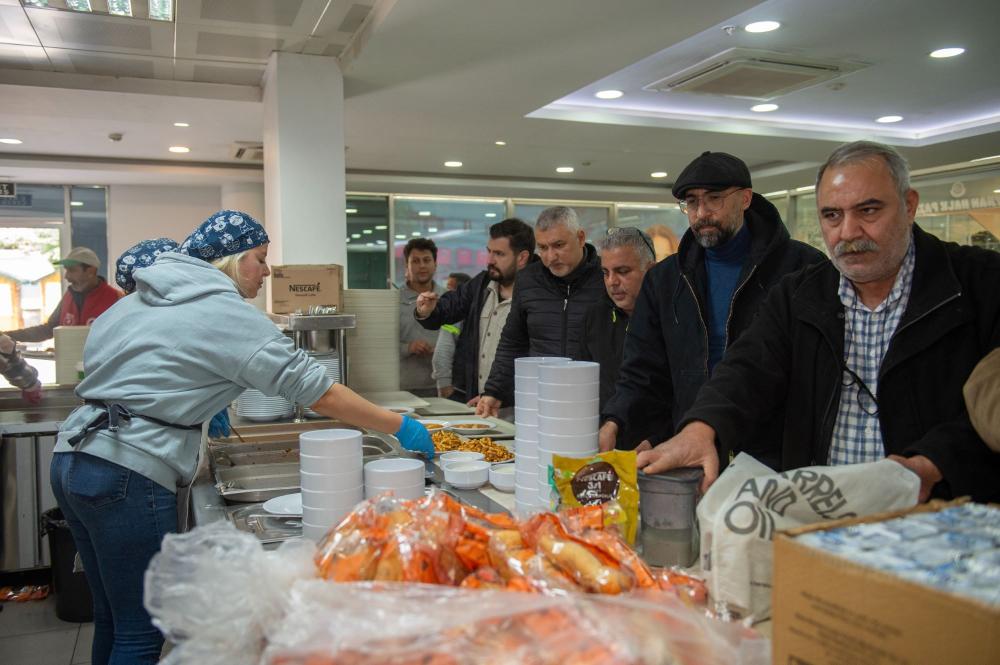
<box><xmin>261</xmin><ymin>581</ymin><xmax>770</xmax><ymax>665</ymax></box>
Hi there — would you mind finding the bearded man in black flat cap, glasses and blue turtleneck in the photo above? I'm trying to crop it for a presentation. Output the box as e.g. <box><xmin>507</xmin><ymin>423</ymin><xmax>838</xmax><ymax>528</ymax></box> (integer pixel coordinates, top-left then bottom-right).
<box><xmin>600</xmin><ymin>152</ymin><xmax>826</xmax><ymax>463</ymax></box>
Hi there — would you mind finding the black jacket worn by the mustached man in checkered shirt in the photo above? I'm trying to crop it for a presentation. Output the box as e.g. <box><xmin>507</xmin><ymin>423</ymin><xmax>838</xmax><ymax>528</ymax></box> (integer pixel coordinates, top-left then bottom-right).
<box><xmin>682</xmin><ymin>225</ymin><xmax>1000</xmax><ymax>502</ymax></box>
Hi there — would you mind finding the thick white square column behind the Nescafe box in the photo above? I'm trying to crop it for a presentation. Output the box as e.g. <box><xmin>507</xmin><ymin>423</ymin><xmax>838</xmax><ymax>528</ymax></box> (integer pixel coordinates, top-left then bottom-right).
<box><xmin>264</xmin><ymin>53</ymin><xmax>347</xmax><ymax>278</ymax></box>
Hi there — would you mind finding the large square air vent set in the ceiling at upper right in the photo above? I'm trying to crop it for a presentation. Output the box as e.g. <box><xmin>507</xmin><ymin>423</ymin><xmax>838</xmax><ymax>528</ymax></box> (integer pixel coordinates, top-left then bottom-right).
<box><xmin>645</xmin><ymin>48</ymin><xmax>867</xmax><ymax>100</ymax></box>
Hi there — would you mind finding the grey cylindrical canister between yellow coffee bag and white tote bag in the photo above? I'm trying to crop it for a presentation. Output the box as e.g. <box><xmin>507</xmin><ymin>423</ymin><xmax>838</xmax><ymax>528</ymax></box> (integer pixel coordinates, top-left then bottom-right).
<box><xmin>639</xmin><ymin>468</ymin><xmax>705</xmax><ymax>567</ymax></box>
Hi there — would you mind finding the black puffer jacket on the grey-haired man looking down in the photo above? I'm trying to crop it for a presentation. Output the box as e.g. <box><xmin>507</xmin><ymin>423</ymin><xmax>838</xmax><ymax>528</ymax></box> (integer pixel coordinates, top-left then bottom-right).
<box><xmin>483</xmin><ymin>244</ymin><xmax>606</xmax><ymax>406</ymax></box>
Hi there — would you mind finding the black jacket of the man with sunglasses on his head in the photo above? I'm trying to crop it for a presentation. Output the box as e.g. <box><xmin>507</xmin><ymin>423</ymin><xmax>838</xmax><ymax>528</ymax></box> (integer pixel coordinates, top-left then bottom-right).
<box><xmin>580</xmin><ymin>296</ymin><xmax>665</xmax><ymax>450</ymax></box>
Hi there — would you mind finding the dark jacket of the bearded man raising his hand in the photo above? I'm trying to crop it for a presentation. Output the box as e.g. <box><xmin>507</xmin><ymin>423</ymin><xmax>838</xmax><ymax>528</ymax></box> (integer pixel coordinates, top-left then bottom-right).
<box><xmin>414</xmin><ymin>270</ymin><xmax>490</xmax><ymax>400</ymax></box>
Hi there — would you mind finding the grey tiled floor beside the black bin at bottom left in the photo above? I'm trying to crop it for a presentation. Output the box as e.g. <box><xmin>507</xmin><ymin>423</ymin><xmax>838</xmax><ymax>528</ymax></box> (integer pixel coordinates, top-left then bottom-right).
<box><xmin>0</xmin><ymin>596</ymin><xmax>94</xmax><ymax>665</ymax></box>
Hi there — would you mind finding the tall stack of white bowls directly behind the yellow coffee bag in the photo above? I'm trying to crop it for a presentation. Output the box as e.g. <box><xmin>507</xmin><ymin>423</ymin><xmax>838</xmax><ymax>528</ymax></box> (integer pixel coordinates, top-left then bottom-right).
<box><xmin>537</xmin><ymin>361</ymin><xmax>601</xmax><ymax>507</ymax></box>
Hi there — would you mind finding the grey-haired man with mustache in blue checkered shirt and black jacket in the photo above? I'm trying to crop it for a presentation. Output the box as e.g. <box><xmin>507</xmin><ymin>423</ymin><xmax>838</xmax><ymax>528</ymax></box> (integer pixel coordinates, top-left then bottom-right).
<box><xmin>637</xmin><ymin>141</ymin><xmax>1000</xmax><ymax>502</ymax></box>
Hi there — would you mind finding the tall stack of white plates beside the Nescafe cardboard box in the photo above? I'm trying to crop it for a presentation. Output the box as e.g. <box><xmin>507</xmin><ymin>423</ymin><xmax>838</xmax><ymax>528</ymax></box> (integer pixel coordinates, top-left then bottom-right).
<box><xmin>344</xmin><ymin>289</ymin><xmax>399</xmax><ymax>392</ymax></box>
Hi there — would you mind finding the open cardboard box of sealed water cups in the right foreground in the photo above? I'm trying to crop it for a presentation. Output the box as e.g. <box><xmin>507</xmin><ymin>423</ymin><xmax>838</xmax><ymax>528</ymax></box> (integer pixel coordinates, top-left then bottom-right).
<box><xmin>772</xmin><ymin>501</ymin><xmax>1000</xmax><ymax>665</ymax></box>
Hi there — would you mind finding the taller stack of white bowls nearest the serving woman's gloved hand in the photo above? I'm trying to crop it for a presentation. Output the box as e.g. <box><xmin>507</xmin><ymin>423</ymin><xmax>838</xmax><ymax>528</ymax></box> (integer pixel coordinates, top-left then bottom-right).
<box><xmin>299</xmin><ymin>429</ymin><xmax>365</xmax><ymax>541</ymax></box>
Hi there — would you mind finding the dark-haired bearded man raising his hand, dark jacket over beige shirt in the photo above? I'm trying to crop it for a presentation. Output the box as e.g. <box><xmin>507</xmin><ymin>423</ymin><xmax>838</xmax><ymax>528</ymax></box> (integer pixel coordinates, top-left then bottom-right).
<box><xmin>413</xmin><ymin>218</ymin><xmax>536</xmax><ymax>406</ymax></box>
